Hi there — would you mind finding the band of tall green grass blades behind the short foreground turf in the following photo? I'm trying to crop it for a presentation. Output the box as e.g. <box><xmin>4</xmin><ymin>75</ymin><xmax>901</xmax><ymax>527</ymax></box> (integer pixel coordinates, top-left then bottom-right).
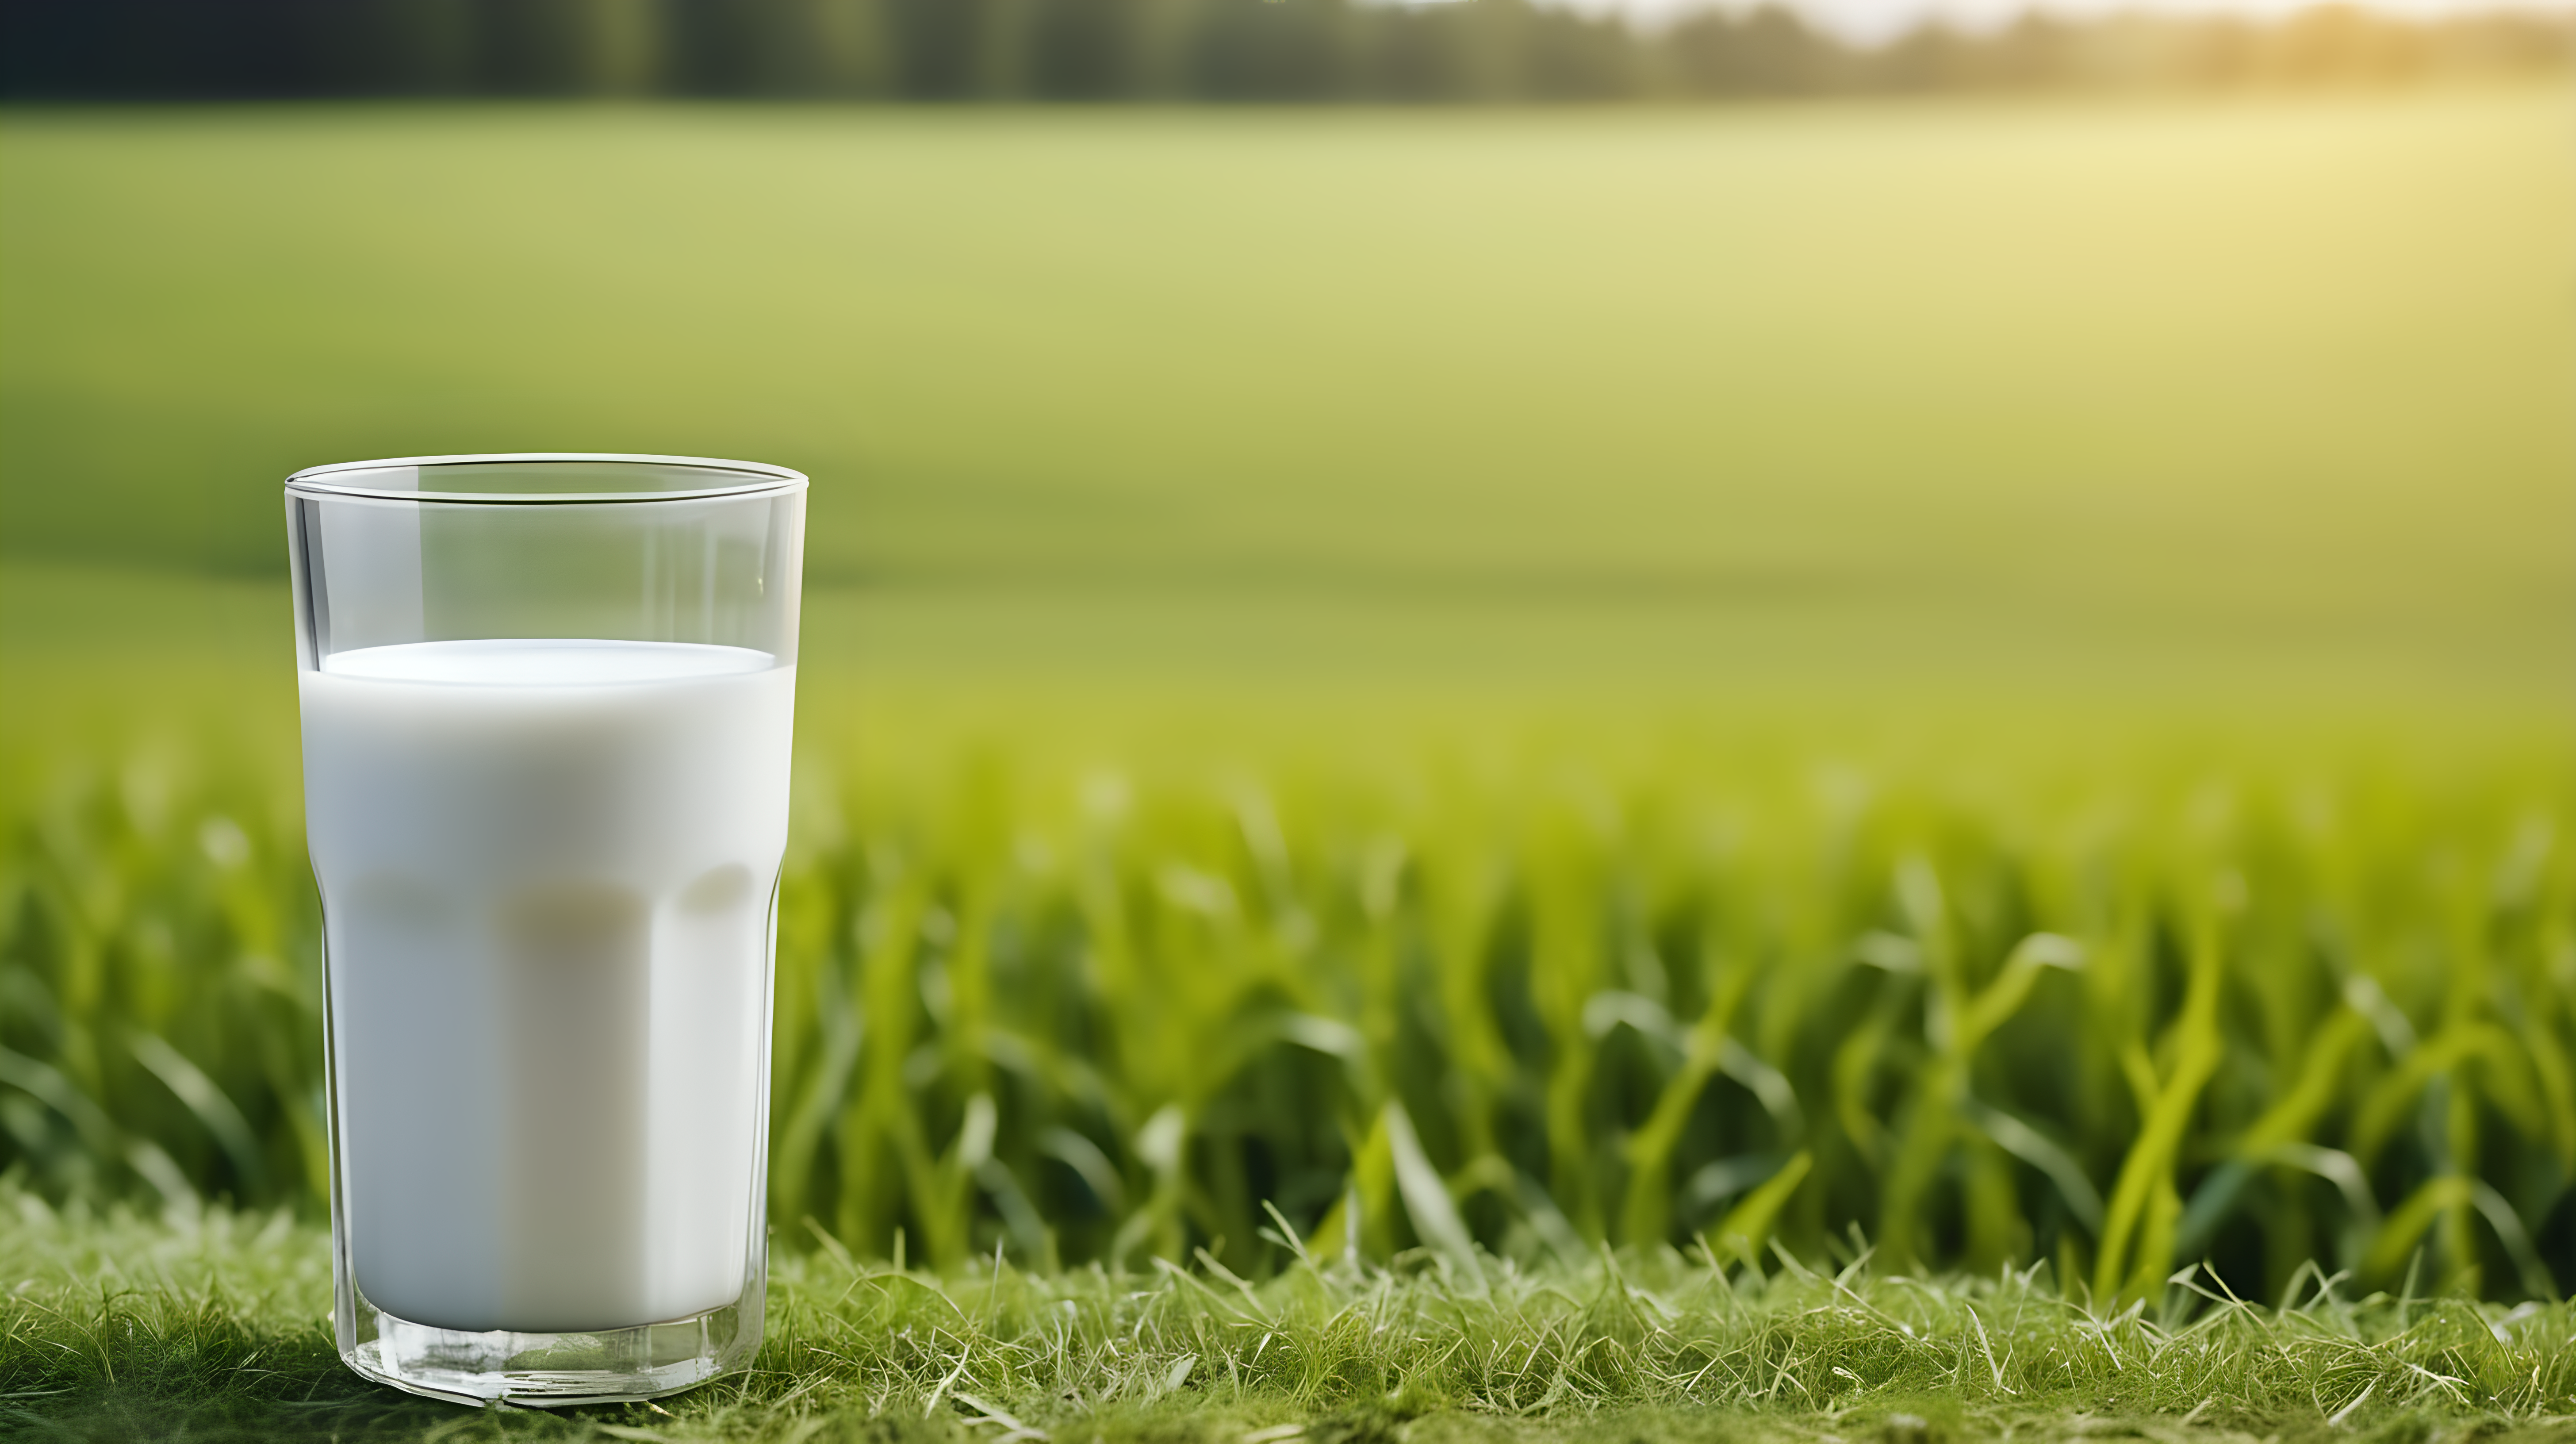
<box><xmin>0</xmin><ymin>676</ymin><xmax>2576</xmax><ymax>1302</ymax></box>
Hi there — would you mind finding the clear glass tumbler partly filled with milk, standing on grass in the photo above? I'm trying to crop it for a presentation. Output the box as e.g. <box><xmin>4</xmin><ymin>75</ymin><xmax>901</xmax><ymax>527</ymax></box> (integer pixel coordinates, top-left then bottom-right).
<box><xmin>286</xmin><ymin>454</ymin><xmax>806</xmax><ymax>1406</ymax></box>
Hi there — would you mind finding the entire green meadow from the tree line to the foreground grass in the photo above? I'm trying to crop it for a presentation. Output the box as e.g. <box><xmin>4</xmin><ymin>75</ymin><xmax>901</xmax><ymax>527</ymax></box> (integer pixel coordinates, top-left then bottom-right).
<box><xmin>0</xmin><ymin>88</ymin><xmax>2576</xmax><ymax>1444</ymax></box>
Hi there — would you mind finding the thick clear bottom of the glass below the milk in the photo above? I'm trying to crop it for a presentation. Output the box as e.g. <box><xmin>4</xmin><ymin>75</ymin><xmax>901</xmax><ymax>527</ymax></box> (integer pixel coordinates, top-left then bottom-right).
<box><xmin>340</xmin><ymin>1289</ymin><xmax>760</xmax><ymax>1408</ymax></box>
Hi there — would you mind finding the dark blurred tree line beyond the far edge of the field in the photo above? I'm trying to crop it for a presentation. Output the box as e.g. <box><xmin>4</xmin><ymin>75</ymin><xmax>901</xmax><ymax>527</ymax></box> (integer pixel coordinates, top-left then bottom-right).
<box><xmin>0</xmin><ymin>0</ymin><xmax>2576</xmax><ymax>100</ymax></box>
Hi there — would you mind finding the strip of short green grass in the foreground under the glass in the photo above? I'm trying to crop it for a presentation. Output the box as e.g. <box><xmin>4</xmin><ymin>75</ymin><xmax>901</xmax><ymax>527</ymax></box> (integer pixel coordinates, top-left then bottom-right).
<box><xmin>0</xmin><ymin>1189</ymin><xmax>2576</xmax><ymax>1444</ymax></box>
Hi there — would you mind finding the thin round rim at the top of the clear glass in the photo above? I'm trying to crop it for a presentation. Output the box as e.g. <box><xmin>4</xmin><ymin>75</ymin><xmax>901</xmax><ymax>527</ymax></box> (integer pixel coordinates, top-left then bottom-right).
<box><xmin>286</xmin><ymin>451</ymin><xmax>806</xmax><ymax>503</ymax></box>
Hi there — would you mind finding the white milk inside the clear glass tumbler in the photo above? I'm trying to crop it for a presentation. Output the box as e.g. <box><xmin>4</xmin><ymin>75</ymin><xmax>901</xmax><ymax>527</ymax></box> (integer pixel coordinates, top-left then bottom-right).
<box><xmin>301</xmin><ymin>642</ymin><xmax>796</xmax><ymax>1333</ymax></box>
